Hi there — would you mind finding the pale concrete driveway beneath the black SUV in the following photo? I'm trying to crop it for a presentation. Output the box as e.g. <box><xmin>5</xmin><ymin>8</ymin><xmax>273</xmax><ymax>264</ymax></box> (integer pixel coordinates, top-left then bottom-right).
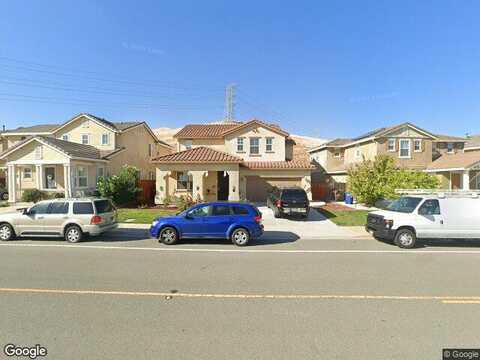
<box><xmin>258</xmin><ymin>206</ymin><xmax>358</xmax><ymax>239</ymax></box>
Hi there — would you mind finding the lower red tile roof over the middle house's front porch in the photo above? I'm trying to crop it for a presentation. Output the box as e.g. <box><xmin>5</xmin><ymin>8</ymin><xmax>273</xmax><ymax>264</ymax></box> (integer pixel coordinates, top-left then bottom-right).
<box><xmin>153</xmin><ymin>146</ymin><xmax>242</xmax><ymax>164</ymax></box>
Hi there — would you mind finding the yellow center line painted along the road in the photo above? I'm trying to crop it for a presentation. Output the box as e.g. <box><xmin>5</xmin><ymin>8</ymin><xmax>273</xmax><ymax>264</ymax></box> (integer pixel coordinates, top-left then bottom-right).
<box><xmin>0</xmin><ymin>288</ymin><xmax>480</xmax><ymax>304</ymax></box>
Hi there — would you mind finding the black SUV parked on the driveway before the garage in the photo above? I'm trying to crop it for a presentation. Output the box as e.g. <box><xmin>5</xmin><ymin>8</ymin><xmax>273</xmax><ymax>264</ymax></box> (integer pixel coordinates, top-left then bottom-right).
<box><xmin>267</xmin><ymin>187</ymin><xmax>310</xmax><ymax>218</ymax></box>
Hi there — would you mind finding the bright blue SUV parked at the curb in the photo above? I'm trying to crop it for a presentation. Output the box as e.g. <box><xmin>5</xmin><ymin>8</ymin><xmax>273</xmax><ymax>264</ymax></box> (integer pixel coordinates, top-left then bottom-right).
<box><xmin>150</xmin><ymin>202</ymin><xmax>263</xmax><ymax>246</ymax></box>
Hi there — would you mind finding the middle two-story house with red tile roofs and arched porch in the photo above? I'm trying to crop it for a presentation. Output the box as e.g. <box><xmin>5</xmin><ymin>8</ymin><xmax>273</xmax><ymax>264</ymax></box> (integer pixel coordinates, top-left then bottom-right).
<box><xmin>153</xmin><ymin>119</ymin><xmax>312</xmax><ymax>204</ymax></box>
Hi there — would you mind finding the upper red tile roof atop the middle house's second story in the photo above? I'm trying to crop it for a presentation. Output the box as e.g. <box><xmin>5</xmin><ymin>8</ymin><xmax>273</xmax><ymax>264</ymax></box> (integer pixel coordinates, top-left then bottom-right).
<box><xmin>174</xmin><ymin>119</ymin><xmax>289</xmax><ymax>139</ymax></box>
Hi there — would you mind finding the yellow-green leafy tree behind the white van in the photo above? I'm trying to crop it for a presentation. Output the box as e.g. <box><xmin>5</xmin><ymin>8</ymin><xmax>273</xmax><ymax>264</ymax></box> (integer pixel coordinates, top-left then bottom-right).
<box><xmin>347</xmin><ymin>155</ymin><xmax>439</xmax><ymax>206</ymax></box>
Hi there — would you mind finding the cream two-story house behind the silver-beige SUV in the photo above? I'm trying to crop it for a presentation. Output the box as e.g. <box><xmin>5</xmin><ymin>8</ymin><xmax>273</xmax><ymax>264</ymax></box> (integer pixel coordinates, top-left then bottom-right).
<box><xmin>0</xmin><ymin>113</ymin><xmax>173</xmax><ymax>202</ymax></box>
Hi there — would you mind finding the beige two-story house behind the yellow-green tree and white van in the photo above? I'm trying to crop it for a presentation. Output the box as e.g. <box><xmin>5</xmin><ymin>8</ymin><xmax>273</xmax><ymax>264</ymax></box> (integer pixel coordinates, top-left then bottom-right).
<box><xmin>309</xmin><ymin>123</ymin><xmax>466</xmax><ymax>200</ymax></box>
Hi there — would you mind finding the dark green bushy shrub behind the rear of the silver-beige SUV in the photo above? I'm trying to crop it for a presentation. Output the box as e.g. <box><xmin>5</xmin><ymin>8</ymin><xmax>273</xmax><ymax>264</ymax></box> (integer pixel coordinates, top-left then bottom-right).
<box><xmin>97</xmin><ymin>165</ymin><xmax>142</xmax><ymax>206</ymax></box>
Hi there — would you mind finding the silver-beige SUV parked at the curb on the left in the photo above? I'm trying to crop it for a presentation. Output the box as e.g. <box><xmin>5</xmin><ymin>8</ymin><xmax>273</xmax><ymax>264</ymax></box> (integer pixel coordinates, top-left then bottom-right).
<box><xmin>0</xmin><ymin>198</ymin><xmax>118</xmax><ymax>243</ymax></box>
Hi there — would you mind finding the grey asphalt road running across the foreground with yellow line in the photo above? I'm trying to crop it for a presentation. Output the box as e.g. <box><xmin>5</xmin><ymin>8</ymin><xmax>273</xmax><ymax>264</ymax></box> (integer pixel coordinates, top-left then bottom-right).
<box><xmin>0</xmin><ymin>230</ymin><xmax>480</xmax><ymax>360</ymax></box>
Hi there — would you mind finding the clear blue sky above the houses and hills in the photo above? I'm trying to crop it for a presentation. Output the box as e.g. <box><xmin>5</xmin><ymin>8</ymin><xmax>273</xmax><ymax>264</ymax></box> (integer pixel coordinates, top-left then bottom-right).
<box><xmin>0</xmin><ymin>0</ymin><xmax>480</xmax><ymax>138</ymax></box>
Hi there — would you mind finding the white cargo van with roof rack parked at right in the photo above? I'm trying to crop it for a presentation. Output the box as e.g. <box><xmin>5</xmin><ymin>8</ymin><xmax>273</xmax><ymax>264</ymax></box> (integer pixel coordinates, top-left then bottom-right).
<box><xmin>365</xmin><ymin>191</ymin><xmax>480</xmax><ymax>248</ymax></box>
